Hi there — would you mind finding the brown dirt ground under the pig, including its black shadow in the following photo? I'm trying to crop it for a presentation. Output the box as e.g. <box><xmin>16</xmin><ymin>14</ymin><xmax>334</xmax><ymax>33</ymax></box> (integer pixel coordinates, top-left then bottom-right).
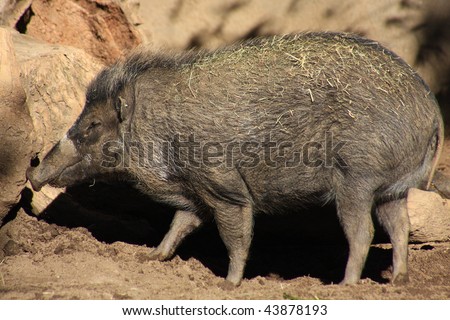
<box><xmin>0</xmin><ymin>141</ymin><xmax>450</xmax><ymax>299</ymax></box>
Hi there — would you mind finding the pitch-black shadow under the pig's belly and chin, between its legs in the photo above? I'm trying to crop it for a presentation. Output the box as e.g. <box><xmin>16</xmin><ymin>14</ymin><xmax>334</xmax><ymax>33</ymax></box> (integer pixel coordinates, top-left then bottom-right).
<box><xmin>24</xmin><ymin>184</ymin><xmax>391</xmax><ymax>284</ymax></box>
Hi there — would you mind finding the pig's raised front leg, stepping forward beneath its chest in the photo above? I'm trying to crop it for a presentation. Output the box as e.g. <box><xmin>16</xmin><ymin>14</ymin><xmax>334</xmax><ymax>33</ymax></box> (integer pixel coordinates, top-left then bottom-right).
<box><xmin>149</xmin><ymin>210</ymin><xmax>203</xmax><ymax>261</ymax></box>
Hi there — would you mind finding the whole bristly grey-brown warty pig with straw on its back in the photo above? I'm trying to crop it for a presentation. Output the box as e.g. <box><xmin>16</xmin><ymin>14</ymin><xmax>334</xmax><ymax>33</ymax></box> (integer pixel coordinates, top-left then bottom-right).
<box><xmin>27</xmin><ymin>32</ymin><xmax>443</xmax><ymax>285</ymax></box>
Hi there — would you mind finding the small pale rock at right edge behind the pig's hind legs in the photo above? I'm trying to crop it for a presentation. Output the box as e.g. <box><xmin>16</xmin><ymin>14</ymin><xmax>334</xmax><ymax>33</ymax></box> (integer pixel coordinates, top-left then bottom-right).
<box><xmin>407</xmin><ymin>189</ymin><xmax>450</xmax><ymax>243</ymax></box>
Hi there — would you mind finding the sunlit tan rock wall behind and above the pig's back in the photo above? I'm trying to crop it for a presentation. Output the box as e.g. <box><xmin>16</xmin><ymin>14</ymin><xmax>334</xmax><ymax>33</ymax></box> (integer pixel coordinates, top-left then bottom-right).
<box><xmin>120</xmin><ymin>0</ymin><xmax>412</xmax><ymax>49</ymax></box>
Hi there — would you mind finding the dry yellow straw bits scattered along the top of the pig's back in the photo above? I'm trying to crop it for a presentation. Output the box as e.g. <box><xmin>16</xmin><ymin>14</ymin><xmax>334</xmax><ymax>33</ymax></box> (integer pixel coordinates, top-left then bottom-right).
<box><xmin>187</xmin><ymin>33</ymin><xmax>415</xmax><ymax>94</ymax></box>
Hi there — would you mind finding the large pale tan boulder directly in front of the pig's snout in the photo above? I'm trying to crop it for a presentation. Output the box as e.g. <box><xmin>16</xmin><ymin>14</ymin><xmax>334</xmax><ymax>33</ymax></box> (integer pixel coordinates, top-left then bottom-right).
<box><xmin>0</xmin><ymin>28</ymin><xmax>102</xmax><ymax>221</ymax></box>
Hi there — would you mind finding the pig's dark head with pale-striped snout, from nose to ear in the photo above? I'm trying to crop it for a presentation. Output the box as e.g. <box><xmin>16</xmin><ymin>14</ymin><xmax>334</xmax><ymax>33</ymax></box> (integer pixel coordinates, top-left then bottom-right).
<box><xmin>27</xmin><ymin>70</ymin><xmax>132</xmax><ymax>190</ymax></box>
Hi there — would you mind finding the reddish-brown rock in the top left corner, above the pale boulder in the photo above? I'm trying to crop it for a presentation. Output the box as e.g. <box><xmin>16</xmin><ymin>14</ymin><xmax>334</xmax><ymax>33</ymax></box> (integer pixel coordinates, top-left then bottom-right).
<box><xmin>0</xmin><ymin>0</ymin><xmax>141</xmax><ymax>63</ymax></box>
